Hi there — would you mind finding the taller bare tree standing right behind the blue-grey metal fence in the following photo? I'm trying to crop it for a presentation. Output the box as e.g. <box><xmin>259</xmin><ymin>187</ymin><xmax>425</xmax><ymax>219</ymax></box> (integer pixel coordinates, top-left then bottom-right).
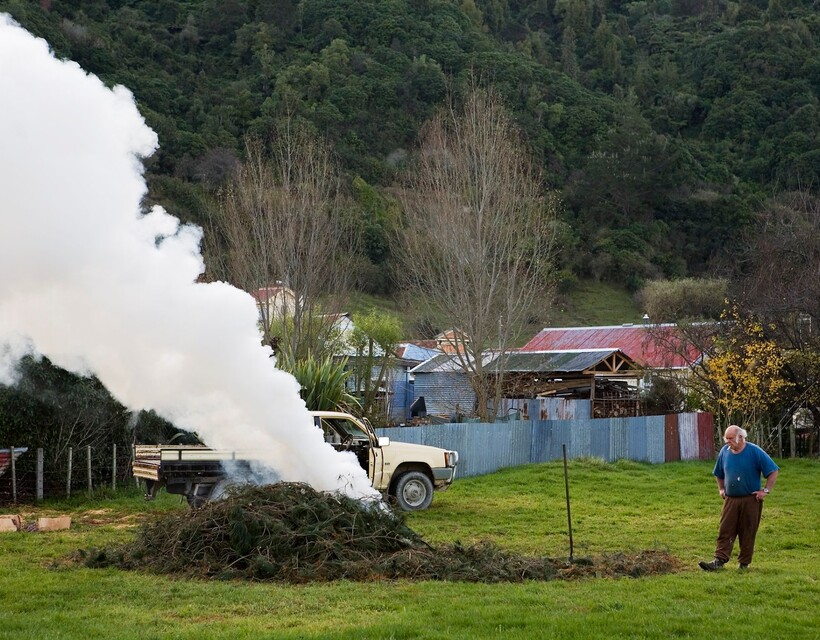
<box><xmin>398</xmin><ymin>87</ymin><xmax>558</xmax><ymax>419</ymax></box>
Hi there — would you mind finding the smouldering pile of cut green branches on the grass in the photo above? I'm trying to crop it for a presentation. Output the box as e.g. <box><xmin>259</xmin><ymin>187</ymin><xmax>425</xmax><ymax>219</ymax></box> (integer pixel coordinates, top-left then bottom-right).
<box><xmin>80</xmin><ymin>483</ymin><xmax>675</xmax><ymax>583</ymax></box>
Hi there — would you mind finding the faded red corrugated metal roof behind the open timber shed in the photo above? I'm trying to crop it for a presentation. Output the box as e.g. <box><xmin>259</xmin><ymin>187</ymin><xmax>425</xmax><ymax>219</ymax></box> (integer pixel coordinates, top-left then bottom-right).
<box><xmin>521</xmin><ymin>324</ymin><xmax>702</xmax><ymax>369</ymax></box>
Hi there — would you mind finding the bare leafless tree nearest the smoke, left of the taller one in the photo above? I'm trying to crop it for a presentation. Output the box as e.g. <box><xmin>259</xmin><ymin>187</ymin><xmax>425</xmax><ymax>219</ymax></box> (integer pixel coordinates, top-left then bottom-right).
<box><xmin>206</xmin><ymin>120</ymin><xmax>356</xmax><ymax>362</ymax></box>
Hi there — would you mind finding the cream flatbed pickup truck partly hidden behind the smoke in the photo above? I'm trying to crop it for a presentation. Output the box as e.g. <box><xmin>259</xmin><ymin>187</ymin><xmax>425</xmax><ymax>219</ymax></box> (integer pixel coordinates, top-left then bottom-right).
<box><xmin>133</xmin><ymin>411</ymin><xmax>458</xmax><ymax>511</ymax></box>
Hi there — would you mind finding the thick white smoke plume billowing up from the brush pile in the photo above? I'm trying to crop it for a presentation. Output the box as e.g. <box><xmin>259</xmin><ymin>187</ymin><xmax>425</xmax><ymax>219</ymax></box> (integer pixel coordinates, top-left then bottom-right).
<box><xmin>0</xmin><ymin>14</ymin><xmax>378</xmax><ymax>497</ymax></box>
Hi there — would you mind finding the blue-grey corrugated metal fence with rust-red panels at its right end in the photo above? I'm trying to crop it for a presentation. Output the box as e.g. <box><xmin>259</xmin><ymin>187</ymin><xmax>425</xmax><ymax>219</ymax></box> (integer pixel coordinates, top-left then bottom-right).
<box><xmin>376</xmin><ymin>413</ymin><xmax>715</xmax><ymax>477</ymax></box>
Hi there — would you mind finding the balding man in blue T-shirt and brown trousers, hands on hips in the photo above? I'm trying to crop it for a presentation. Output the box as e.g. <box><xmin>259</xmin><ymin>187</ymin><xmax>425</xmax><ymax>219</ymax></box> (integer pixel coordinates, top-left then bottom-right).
<box><xmin>699</xmin><ymin>424</ymin><xmax>780</xmax><ymax>571</ymax></box>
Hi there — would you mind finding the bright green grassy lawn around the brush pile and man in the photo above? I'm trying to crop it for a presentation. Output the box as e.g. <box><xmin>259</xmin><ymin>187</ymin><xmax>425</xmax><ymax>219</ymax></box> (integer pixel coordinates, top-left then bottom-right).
<box><xmin>0</xmin><ymin>460</ymin><xmax>820</xmax><ymax>640</ymax></box>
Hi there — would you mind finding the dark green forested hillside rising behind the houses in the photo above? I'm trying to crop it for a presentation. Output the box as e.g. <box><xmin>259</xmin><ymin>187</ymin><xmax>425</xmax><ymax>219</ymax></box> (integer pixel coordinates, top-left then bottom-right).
<box><xmin>0</xmin><ymin>0</ymin><xmax>820</xmax><ymax>293</ymax></box>
